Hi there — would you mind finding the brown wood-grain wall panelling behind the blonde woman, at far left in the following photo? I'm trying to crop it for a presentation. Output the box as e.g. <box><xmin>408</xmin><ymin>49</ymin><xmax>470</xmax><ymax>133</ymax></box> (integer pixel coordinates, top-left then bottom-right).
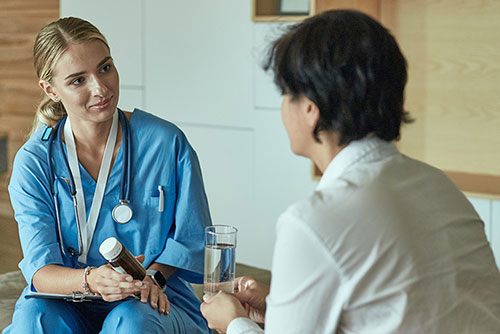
<box><xmin>0</xmin><ymin>0</ymin><xmax>59</xmax><ymax>223</ymax></box>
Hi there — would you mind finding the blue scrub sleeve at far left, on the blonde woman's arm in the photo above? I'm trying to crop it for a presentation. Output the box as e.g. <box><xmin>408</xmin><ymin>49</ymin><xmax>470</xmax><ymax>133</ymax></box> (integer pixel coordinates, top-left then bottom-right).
<box><xmin>9</xmin><ymin>148</ymin><xmax>64</xmax><ymax>283</ymax></box>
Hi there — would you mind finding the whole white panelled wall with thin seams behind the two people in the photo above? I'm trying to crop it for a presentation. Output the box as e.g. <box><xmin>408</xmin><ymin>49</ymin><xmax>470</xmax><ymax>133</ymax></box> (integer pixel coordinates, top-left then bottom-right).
<box><xmin>60</xmin><ymin>0</ymin><xmax>500</xmax><ymax>268</ymax></box>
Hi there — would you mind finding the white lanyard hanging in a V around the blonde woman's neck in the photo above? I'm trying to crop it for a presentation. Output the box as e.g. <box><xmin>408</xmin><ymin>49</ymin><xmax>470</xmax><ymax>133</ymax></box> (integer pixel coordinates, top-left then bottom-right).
<box><xmin>64</xmin><ymin>112</ymin><xmax>118</xmax><ymax>263</ymax></box>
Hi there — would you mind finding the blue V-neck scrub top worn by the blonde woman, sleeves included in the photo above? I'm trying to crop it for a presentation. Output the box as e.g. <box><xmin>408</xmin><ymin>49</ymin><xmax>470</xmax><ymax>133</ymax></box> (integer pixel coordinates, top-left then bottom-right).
<box><xmin>9</xmin><ymin>109</ymin><xmax>211</xmax><ymax>306</ymax></box>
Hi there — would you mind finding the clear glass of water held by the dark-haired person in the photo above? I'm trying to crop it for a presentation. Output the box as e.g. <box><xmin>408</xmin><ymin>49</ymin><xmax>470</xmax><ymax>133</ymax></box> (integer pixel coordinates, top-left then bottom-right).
<box><xmin>203</xmin><ymin>225</ymin><xmax>238</xmax><ymax>295</ymax></box>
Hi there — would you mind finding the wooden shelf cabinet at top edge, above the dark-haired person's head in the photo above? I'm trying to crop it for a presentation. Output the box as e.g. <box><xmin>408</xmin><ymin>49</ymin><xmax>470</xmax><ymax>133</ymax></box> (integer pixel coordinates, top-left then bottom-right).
<box><xmin>252</xmin><ymin>0</ymin><xmax>380</xmax><ymax>22</ymax></box>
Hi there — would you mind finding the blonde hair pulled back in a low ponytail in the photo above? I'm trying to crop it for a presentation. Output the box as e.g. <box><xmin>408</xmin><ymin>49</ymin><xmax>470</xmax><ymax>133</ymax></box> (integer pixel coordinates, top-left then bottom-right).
<box><xmin>29</xmin><ymin>17</ymin><xmax>109</xmax><ymax>136</ymax></box>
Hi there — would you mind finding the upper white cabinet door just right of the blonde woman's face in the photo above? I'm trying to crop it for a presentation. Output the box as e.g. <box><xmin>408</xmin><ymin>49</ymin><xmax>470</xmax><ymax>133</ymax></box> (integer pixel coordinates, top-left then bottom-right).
<box><xmin>144</xmin><ymin>0</ymin><xmax>253</xmax><ymax>127</ymax></box>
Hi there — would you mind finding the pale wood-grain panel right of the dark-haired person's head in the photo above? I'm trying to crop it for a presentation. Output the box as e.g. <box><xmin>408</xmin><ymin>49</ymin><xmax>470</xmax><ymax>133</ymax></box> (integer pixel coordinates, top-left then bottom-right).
<box><xmin>381</xmin><ymin>0</ymin><xmax>500</xmax><ymax>194</ymax></box>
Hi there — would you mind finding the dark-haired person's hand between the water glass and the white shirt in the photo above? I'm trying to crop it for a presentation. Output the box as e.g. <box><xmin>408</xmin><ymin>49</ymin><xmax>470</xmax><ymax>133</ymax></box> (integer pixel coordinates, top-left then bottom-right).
<box><xmin>234</xmin><ymin>276</ymin><xmax>269</xmax><ymax>324</ymax></box>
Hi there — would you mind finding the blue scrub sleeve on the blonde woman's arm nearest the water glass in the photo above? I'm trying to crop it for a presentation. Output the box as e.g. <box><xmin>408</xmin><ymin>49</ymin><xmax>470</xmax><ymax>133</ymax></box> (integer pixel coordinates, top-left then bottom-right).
<box><xmin>156</xmin><ymin>141</ymin><xmax>211</xmax><ymax>283</ymax></box>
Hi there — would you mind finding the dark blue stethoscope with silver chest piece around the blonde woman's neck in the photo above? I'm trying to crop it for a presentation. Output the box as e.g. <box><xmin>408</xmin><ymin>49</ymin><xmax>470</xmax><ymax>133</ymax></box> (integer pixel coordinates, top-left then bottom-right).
<box><xmin>46</xmin><ymin>109</ymin><xmax>133</xmax><ymax>257</ymax></box>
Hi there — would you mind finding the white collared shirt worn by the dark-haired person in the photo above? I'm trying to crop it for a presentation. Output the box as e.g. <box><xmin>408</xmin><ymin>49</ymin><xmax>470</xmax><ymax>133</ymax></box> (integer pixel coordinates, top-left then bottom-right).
<box><xmin>227</xmin><ymin>136</ymin><xmax>500</xmax><ymax>334</ymax></box>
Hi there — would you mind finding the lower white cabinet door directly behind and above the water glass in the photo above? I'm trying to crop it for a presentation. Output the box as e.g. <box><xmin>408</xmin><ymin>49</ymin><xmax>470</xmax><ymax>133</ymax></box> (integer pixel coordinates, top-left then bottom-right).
<box><xmin>178</xmin><ymin>123</ymin><xmax>256</xmax><ymax>263</ymax></box>
